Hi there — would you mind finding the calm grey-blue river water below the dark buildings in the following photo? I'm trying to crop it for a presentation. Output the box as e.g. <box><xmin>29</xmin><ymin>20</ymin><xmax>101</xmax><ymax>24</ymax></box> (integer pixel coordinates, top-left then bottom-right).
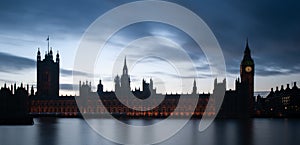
<box><xmin>0</xmin><ymin>119</ymin><xmax>300</xmax><ymax>145</ymax></box>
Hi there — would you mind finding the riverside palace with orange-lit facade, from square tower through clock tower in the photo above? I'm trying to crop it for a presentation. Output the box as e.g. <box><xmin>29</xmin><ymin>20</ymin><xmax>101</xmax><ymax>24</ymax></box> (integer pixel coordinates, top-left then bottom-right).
<box><xmin>30</xmin><ymin>41</ymin><xmax>255</xmax><ymax>118</ymax></box>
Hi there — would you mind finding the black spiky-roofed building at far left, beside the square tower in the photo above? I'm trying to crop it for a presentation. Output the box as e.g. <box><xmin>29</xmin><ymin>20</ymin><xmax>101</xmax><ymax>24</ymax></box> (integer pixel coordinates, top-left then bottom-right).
<box><xmin>0</xmin><ymin>83</ymin><xmax>34</xmax><ymax>124</ymax></box>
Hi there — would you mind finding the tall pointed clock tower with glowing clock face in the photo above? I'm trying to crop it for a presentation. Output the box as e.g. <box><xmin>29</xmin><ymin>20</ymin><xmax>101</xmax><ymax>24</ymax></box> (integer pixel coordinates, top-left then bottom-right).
<box><xmin>240</xmin><ymin>40</ymin><xmax>255</xmax><ymax>116</ymax></box>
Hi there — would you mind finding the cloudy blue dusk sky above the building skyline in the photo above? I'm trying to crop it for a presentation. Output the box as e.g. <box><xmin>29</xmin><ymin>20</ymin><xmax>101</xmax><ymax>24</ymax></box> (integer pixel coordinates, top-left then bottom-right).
<box><xmin>0</xmin><ymin>0</ymin><xmax>300</xmax><ymax>95</ymax></box>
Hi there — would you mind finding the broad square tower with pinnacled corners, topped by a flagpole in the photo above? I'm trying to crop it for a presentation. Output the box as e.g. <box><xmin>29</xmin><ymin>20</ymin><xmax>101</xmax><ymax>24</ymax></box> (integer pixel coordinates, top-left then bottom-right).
<box><xmin>37</xmin><ymin>40</ymin><xmax>59</xmax><ymax>97</ymax></box>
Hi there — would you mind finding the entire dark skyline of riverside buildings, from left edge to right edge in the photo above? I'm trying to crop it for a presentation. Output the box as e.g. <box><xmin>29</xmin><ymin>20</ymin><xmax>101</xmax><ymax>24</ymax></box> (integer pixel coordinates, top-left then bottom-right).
<box><xmin>0</xmin><ymin>41</ymin><xmax>300</xmax><ymax>123</ymax></box>
